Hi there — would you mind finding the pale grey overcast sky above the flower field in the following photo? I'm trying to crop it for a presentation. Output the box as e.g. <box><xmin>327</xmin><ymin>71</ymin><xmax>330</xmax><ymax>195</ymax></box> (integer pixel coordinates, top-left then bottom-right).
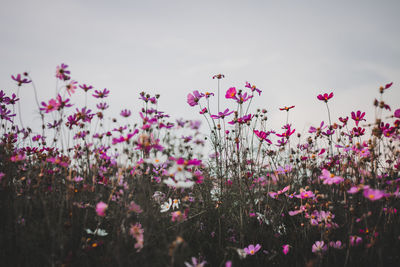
<box><xmin>0</xmin><ymin>0</ymin><xmax>400</xmax><ymax>137</ymax></box>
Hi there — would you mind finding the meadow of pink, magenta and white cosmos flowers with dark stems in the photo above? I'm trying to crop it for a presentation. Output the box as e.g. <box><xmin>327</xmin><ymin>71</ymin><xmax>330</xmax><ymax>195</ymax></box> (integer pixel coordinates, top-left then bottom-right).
<box><xmin>0</xmin><ymin>64</ymin><xmax>400</xmax><ymax>266</ymax></box>
